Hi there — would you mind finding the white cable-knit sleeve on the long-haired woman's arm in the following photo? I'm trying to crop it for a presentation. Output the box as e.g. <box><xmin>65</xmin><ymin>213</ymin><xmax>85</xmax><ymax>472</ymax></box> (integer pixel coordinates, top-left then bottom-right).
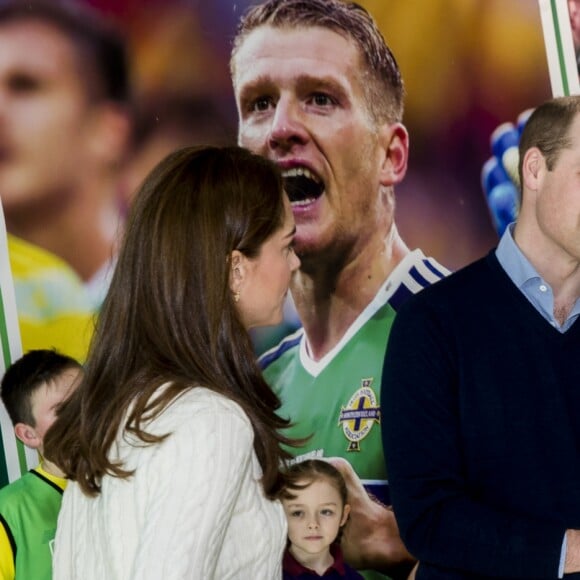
<box><xmin>131</xmin><ymin>396</ymin><xmax>253</xmax><ymax>580</ymax></box>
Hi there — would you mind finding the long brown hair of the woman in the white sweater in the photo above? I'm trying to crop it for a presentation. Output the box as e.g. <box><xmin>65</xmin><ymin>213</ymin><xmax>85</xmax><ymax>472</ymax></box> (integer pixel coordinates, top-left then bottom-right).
<box><xmin>44</xmin><ymin>147</ymin><xmax>292</xmax><ymax>497</ymax></box>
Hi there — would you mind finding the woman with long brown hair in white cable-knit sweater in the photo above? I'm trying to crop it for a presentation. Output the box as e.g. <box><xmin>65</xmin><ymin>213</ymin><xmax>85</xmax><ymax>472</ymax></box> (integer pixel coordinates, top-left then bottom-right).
<box><xmin>45</xmin><ymin>147</ymin><xmax>299</xmax><ymax>580</ymax></box>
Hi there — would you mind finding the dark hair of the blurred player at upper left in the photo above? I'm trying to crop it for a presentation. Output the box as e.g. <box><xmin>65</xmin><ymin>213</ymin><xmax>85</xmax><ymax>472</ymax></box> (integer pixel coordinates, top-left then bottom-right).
<box><xmin>0</xmin><ymin>0</ymin><xmax>130</xmax><ymax>105</ymax></box>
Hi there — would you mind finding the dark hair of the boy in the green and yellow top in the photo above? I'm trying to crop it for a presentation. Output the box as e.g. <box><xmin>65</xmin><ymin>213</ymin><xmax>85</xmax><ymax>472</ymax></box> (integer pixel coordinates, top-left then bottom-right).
<box><xmin>0</xmin><ymin>350</ymin><xmax>82</xmax><ymax>427</ymax></box>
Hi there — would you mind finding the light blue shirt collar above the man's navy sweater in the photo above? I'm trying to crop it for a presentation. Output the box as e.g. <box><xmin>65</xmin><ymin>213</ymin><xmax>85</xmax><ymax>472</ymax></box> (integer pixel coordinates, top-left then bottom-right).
<box><xmin>495</xmin><ymin>224</ymin><xmax>580</xmax><ymax>332</ymax></box>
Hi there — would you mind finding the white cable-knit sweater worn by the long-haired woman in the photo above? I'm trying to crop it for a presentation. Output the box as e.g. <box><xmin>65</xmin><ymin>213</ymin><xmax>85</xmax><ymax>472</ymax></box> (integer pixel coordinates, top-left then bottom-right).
<box><xmin>54</xmin><ymin>387</ymin><xmax>286</xmax><ymax>580</ymax></box>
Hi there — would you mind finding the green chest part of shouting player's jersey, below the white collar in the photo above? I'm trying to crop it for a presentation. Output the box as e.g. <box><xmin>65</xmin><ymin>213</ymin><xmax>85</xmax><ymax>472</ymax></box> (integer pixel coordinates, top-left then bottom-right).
<box><xmin>264</xmin><ymin>303</ymin><xmax>395</xmax><ymax>501</ymax></box>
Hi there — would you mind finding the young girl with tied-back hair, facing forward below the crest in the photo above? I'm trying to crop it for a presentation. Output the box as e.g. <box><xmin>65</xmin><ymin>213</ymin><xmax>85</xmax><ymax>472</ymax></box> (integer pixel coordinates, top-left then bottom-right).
<box><xmin>282</xmin><ymin>459</ymin><xmax>363</xmax><ymax>580</ymax></box>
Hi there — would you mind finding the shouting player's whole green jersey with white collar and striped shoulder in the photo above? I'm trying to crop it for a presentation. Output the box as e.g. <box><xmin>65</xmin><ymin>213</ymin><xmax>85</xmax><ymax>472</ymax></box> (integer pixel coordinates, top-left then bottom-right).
<box><xmin>260</xmin><ymin>250</ymin><xmax>449</xmax><ymax>579</ymax></box>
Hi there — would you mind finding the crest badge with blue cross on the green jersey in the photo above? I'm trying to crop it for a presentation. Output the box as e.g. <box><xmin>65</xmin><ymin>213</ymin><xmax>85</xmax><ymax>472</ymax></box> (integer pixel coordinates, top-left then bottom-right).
<box><xmin>338</xmin><ymin>377</ymin><xmax>381</xmax><ymax>451</ymax></box>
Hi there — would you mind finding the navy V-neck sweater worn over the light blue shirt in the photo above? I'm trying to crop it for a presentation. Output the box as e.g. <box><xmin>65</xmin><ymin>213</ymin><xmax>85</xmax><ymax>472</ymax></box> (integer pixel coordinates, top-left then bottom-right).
<box><xmin>382</xmin><ymin>253</ymin><xmax>580</xmax><ymax>580</ymax></box>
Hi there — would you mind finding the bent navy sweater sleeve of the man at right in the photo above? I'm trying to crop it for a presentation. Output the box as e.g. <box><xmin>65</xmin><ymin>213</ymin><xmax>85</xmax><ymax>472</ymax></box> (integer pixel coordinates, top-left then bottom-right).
<box><xmin>382</xmin><ymin>301</ymin><xmax>565</xmax><ymax>578</ymax></box>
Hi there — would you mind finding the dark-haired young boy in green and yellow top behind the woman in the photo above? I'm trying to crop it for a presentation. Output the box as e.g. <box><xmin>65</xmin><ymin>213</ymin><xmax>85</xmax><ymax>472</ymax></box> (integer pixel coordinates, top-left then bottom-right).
<box><xmin>0</xmin><ymin>350</ymin><xmax>82</xmax><ymax>580</ymax></box>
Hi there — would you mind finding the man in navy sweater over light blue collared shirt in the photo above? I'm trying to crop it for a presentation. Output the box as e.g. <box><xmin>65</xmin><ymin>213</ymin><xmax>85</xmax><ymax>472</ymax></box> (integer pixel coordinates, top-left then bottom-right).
<box><xmin>382</xmin><ymin>96</ymin><xmax>580</xmax><ymax>579</ymax></box>
